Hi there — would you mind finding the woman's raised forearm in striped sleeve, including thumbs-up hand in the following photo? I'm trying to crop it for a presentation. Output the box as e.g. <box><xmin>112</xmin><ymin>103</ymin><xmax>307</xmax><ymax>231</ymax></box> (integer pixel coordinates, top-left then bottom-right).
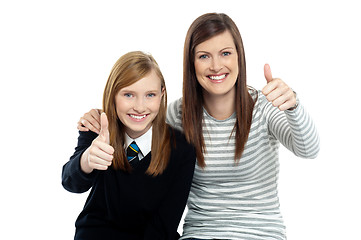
<box><xmin>262</xmin><ymin>64</ymin><xmax>319</xmax><ymax>158</ymax></box>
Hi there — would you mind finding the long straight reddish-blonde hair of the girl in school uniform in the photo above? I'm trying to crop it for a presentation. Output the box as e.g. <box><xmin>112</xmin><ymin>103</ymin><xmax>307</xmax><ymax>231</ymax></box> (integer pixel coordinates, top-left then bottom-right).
<box><xmin>103</xmin><ymin>51</ymin><xmax>170</xmax><ymax>176</ymax></box>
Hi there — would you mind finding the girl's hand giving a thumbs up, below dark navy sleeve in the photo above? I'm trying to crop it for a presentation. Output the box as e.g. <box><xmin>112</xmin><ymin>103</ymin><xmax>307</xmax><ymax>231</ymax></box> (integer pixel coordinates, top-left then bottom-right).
<box><xmin>80</xmin><ymin>113</ymin><xmax>114</xmax><ymax>173</ymax></box>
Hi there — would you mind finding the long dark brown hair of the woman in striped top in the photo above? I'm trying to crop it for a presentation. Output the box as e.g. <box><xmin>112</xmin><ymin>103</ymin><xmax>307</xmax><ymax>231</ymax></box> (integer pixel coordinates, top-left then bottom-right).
<box><xmin>182</xmin><ymin>13</ymin><xmax>254</xmax><ymax>167</ymax></box>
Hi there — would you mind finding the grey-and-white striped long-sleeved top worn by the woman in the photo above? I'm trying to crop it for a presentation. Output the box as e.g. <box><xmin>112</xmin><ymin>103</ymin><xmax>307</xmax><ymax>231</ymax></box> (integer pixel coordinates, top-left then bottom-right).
<box><xmin>167</xmin><ymin>91</ymin><xmax>319</xmax><ymax>240</ymax></box>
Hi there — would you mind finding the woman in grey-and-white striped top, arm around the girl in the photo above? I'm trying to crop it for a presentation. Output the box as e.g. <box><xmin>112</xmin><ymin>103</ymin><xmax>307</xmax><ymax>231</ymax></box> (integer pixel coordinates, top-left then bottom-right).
<box><xmin>78</xmin><ymin>13</ymin><xmax>319</xmax><ymax>240</ymax></box>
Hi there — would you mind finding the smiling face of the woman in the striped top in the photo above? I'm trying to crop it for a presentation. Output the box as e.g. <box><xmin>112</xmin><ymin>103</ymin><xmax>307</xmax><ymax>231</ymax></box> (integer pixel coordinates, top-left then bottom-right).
<box><xmin>194</xmin><ymin>31</ymin><xmax>238</xmax><ymax>99</ymax></box>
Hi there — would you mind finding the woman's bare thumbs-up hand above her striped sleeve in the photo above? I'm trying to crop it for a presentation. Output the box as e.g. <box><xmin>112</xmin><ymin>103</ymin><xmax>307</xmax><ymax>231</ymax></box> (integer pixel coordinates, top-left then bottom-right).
<box><xmin>262</xmin><ymin>64</ymin><xmax>297</xmax><ymax>111</ymax></box>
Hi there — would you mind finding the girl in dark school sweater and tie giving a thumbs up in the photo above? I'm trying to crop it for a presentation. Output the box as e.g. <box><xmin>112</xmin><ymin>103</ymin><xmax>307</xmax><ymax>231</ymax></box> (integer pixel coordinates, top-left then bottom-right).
<box><xmin>62</xmin><ymin>52</ymin><xmax>195</xmax><ymax>240</ymax></box>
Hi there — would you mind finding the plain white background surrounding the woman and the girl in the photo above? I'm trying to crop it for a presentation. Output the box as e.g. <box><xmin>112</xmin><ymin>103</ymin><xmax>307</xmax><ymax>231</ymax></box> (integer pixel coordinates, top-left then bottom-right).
<box><xmin>0</xmin><ymin>0</ymin><xmax>361</xmax><ymax>240</ymax></box>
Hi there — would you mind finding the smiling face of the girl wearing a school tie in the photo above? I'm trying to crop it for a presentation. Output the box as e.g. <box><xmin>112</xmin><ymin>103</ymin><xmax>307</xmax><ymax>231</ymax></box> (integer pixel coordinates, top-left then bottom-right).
<box><xmin>115</xmin><ymin>70</ymin><xmax>164</xmax><ymax>139</ymax></box>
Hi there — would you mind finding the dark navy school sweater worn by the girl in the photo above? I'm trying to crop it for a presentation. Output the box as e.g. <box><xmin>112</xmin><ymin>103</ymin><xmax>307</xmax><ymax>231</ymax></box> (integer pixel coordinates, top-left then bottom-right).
<box><xmin>62</xmin><ymin>130</ymin><xmax>196</xmax><ymax>240</ymax></box>
